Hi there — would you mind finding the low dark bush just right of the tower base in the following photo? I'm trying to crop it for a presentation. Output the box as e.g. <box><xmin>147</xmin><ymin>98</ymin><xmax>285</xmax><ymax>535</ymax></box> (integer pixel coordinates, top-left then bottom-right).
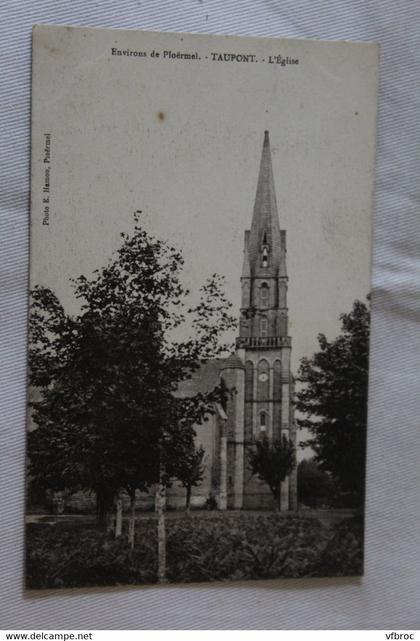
<box><xmin>297</xmin><ymin>459</ymin><xmax>334</xmax><ymax>508</ymax></box>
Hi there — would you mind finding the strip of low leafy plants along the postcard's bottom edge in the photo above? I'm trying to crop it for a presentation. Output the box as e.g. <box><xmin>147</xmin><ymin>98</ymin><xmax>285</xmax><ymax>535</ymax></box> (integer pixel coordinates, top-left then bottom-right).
<box><xmin>27</xmin><ymin>512</ymin><xmax>363</xmax><ymax>588</ymax></box>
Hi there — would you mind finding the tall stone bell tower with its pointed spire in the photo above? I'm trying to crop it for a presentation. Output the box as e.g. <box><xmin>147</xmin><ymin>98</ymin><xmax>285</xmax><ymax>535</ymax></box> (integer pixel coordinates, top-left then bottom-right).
<box><xmin>236</xmin><ymin>131</ymin><xmax>296</xmax><ymax>510</ymax></box>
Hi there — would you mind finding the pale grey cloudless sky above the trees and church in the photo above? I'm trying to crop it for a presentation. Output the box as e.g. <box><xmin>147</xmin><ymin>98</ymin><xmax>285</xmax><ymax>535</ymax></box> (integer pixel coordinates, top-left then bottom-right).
<box><xmin>31</xmin><ymin>27</ymin><xmax>377</xmax><ymax>373</ymax></box>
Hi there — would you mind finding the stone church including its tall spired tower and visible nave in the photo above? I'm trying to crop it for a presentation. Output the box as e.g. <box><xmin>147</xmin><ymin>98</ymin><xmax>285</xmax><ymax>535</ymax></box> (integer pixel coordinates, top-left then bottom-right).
<box><xmin>167</xmin><ymin>131</ymin><xmax>297</xmax><ymax>510</ymax></box>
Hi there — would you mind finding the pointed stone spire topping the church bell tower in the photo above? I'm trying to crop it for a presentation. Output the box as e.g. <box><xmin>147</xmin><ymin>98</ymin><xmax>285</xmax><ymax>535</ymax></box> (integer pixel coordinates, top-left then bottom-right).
<box><xmin>248</xmin><ymin>130</ymin><xmax>281</xmax><ymax>276</ymax></box>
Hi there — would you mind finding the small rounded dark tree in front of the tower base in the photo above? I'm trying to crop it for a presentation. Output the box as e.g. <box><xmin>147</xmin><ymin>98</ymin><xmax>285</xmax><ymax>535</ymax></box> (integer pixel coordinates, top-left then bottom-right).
<box><xmin>248</xmin><ymin>434</ymin><xmax>296</xmax><ymax>509</ymax></box>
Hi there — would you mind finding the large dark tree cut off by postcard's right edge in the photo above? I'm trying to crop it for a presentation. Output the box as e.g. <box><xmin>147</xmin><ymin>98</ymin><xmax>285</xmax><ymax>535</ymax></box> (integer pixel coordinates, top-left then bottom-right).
<box><xmin>296</xmin><ymin>300</ymin><xmax>370</xmax><ymax>502</ymax></box>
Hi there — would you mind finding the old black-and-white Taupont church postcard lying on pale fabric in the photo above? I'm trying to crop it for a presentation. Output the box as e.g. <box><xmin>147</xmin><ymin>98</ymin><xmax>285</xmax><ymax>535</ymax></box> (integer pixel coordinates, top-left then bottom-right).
<box><xmin>26</xmin><ymin>25</ymin><xmax>378</xmax><ymax>589</ymax></box>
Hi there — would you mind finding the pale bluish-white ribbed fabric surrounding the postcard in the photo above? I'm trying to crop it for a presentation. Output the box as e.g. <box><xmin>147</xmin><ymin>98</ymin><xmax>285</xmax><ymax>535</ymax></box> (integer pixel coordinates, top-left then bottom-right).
<box><xmin>0</xmin><ymin>0</ymin><xmax>420</xmax><ymax>629</ymax></box>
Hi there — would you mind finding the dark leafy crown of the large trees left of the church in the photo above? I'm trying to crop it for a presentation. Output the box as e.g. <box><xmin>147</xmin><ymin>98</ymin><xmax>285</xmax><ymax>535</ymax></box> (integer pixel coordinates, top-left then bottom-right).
<box><xmin>28</xmin><ymin>216</ymin><xmax>235</xmax><ymax>511</ymax></box>
